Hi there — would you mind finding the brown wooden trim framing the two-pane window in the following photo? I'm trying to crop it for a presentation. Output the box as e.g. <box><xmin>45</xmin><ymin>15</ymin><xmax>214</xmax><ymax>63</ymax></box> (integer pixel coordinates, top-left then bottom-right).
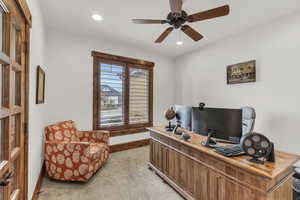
<box><xmin>92</xmin><ymin>51</ymin><xmax>155</xmax><ymax>137</ymax></box>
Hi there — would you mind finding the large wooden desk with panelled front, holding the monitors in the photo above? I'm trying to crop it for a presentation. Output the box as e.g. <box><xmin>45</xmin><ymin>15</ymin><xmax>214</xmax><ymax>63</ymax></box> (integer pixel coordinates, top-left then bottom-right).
<box><xmin>148</xmin><ymin>127</ymin><xmax>300</xmax><ymax>200</ymax></box>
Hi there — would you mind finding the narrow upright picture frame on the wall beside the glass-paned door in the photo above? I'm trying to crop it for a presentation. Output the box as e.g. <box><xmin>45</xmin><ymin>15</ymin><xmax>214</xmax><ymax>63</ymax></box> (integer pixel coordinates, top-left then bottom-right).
<box><xmin>36</xmin><ymin>66</ymin><xmax>46</xmax><ymax>104</ymax></box>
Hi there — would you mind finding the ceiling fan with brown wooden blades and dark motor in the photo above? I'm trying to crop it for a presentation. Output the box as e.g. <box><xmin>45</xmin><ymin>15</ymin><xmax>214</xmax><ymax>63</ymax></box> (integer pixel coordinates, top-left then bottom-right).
<box><xmin>132</xmin><ymin>0</ymin><xmax>230</xmax><ymax>43</ymax></box>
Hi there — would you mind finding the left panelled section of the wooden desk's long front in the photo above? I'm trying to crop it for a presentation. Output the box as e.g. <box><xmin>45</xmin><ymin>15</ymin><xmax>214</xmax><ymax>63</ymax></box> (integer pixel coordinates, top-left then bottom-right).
<box><xmin>150</xmin><ymin>140</ymin><xmax>209</xmax><ymax>200</ymax></box>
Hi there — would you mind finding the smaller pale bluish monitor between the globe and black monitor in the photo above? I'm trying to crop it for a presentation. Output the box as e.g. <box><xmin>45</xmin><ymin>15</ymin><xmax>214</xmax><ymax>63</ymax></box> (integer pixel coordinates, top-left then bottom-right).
<box><xmin>174</xmin><ymin>105</ymin><xmax>192</xmax><ymax>131</ymax></box>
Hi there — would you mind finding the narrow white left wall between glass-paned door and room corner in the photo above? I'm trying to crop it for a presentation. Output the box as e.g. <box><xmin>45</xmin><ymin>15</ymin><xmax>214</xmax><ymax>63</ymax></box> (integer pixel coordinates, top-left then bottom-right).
<box><xmin>28</xmin><ymin>0</ymin><xmax>47</xmax><ymax>199</ymax></box>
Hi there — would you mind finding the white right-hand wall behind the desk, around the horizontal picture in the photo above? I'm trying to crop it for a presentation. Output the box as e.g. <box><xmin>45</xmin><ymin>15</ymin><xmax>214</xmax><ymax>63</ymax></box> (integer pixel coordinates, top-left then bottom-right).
<box><xmin>176</xmin><ymin>13</ymin><xmax>300</xmax><ymax>154</ymax></box>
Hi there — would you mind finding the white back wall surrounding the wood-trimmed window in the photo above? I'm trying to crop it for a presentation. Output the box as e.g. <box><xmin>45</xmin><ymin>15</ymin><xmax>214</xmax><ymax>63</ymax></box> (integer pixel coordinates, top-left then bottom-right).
<box><xmin>46</xmin><ymin>30</ymin><xmax>174</xmax><ymax>144</ymax></box>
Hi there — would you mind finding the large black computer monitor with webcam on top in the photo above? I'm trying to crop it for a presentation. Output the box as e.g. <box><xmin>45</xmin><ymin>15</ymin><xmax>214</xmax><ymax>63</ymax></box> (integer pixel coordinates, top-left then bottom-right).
<box><xmin>192</xmin><ymin>108</ymin><xmax>242</xmax><ymax>143</ymax></box>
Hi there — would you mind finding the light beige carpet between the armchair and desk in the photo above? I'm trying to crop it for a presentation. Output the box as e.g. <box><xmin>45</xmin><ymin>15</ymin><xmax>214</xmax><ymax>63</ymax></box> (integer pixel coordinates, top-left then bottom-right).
<box><xmin>39</xmin><ymin>146</ymin><xmax>183</xmax><ymax>200</ymax></box>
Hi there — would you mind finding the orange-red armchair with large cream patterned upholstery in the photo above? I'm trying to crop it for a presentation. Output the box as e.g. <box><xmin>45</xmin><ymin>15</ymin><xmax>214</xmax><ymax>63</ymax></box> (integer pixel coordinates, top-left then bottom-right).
<box><xmin>45</xmin><ymin>121</ymin><xmax>109</xmax><ymax>181</ymax></box>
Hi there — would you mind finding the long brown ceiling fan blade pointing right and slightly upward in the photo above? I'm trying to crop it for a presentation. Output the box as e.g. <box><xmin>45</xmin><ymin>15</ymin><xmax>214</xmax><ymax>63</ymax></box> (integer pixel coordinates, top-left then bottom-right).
<box><xmin>188</xmin><ymin>5</ymin><xmax>230</xmax><ymax>22</ymax></box>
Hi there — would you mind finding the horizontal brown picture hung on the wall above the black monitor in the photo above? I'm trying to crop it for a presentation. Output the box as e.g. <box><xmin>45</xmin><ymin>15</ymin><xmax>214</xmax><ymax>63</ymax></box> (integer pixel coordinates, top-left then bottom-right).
<box><xmin>227</xmin><ymin>60</ymin><xmax>256</xmax><ymax>85</ymax></box>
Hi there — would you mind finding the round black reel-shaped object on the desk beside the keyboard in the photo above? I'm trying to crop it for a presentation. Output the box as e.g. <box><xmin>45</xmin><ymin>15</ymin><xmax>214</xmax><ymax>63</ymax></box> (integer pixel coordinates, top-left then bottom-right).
<box><xmin>241</xmin><ymin>132</ymin><xmax>275</xmax><ymax>164</ymax></box>
